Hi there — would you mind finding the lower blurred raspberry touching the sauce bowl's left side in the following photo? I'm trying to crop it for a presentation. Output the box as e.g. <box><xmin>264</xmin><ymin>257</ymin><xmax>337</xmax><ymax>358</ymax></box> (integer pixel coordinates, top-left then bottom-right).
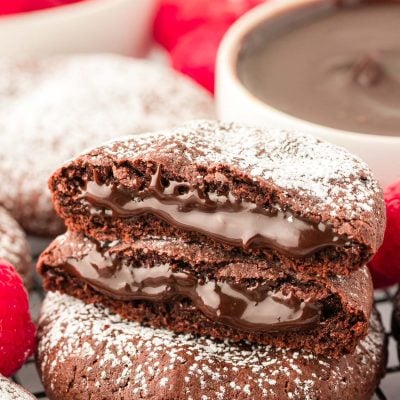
<box><xmin>171</xmin><ymin>24</ymin><xmax>228</xmax><ymax>93</ymax></box>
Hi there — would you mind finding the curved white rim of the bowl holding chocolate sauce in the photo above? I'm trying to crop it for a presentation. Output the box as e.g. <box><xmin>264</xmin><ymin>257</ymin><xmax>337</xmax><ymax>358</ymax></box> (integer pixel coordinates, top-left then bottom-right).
<box><xmin>216</xmin><ymin>0</ymin><xmax>400</xmax><ymax>144</ymax></box>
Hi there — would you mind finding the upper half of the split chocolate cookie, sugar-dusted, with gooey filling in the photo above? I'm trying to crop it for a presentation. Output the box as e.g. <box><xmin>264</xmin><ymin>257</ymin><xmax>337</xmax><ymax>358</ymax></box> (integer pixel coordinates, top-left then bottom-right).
<box><xmin>49</xmin><ymin>121</ymin><xmax>385</xmax><ymax>275</ymax></box>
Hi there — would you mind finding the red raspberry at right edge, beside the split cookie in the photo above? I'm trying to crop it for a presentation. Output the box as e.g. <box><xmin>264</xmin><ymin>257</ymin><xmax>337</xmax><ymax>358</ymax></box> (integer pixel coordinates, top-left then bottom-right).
<box><xmin>369</xmin><ymin>181</ymin><xmax>400</xmax><ymax>287</ymax></box>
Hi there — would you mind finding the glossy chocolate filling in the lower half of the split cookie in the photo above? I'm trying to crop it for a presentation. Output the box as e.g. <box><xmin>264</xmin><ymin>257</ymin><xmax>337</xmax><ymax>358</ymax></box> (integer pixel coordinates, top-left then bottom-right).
<box><xmin>65</xmin><ymin>247</ymin><xmax>321</xmax><ymax>332</ymax></box>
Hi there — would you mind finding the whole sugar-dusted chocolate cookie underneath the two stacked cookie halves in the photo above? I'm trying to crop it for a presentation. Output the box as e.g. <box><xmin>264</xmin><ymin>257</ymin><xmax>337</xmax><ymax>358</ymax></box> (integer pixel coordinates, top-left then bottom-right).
<box><xmin>37</xmin><ymin>294</ymin><xmax>386</xmax><ymax>400</ymax></box>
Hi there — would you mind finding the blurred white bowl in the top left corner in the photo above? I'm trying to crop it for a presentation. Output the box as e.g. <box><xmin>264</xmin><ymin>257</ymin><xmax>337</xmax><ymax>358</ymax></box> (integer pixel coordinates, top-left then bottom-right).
<box><xmin>0</xmin><ymin>0</ymin><xmax>158</xmax><ymax>56</ymax></box>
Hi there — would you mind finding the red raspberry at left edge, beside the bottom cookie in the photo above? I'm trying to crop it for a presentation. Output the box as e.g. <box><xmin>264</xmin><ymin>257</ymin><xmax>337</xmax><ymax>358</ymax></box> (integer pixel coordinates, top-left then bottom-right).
<box><xmin>0</xmin><ymin>260</ymin><xmax>36</xmax><ymax>376</ymax></box>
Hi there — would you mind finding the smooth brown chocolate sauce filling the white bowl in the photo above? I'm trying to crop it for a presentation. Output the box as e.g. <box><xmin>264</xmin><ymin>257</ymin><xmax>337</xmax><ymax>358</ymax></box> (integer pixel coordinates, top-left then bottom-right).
<box><xmin>237</xmin><ymin>1</ymin><xmax>400</xmax><ymax>136</ymax></box>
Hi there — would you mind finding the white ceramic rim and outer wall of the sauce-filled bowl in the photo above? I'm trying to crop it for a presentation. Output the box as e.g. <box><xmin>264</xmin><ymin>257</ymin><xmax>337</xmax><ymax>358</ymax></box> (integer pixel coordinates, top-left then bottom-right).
<box><xmin>216</xmin><ymin>0</ymin><xmax>400</xmax><ymax>187</ymax></box>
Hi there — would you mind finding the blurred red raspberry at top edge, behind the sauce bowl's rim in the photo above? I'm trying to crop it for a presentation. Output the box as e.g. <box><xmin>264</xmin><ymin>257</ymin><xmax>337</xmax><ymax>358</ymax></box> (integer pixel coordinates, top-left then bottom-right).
<box><xmin>154</xmin><ymin>0</ymin><xmax>264</xmax><ymax>50</ymax></box>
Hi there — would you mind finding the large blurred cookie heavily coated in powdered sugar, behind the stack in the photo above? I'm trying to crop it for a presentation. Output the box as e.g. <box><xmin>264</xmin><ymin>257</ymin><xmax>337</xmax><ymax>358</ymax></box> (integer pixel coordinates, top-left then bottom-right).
<box><xmin>0</xmin><ymin>55</ymin><xmax>214</xmax><ymax>236</ymax></box>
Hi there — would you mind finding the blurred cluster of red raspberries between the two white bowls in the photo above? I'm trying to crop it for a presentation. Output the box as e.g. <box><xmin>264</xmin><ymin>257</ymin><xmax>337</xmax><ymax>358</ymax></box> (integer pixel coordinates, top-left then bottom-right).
<box><xmin>154</xmin><ymin>0</ymin><xmax>265</xmax><ymax>92</ymax></box>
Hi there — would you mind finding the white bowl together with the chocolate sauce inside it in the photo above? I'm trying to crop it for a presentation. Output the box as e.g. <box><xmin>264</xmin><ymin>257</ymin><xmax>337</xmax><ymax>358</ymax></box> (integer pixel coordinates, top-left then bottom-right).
<box><xmin>216</xmin><ymin>0</ymin><xmax>400</xmax><ymax>186</ymax></box>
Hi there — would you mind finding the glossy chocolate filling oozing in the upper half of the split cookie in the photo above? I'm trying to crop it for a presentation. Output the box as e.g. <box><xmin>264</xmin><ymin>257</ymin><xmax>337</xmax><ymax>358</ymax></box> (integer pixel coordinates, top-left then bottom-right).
<box><xmin>83</xmin><ymin>169</ymin><xmax>347</xmax><ymax>257</ymax></box>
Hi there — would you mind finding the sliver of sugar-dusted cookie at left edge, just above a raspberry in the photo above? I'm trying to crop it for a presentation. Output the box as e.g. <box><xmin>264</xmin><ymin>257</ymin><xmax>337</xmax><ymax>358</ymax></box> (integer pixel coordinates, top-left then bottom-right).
<box><xmin>0</xmin><ymin>207</ymin><xmax>33</xmax><ymax>287</ymax></box>
